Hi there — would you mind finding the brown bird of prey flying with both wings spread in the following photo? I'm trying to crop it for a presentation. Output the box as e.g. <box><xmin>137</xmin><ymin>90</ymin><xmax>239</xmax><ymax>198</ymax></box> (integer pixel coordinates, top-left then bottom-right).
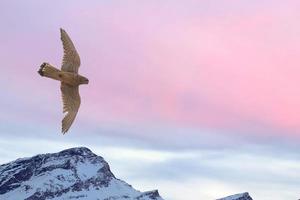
<box><xmin>38</xmin><ymin>28</ymin><xmax>89</xmax><ymax>134</ymax></box>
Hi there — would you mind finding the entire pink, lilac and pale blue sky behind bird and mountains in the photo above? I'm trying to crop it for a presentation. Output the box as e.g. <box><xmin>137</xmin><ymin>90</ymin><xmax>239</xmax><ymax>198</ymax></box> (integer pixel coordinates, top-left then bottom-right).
<box><xmin>0</xmin><ymin>0</ymin><xmax>300</xmax><ymax>200</ymax></box>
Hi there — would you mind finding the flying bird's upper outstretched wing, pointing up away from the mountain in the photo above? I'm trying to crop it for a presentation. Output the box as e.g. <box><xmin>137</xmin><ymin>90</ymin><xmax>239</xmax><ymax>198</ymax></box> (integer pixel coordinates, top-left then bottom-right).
<box><xmin>60</xmin><ymin>28</ymin><xmax>80</xmax><ymax>73</ymax></box>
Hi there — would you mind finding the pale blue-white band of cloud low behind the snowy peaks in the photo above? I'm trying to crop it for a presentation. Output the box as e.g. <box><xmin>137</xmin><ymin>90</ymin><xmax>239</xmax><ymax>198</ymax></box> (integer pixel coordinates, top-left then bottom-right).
<box><xmin>0</xmin><ymin>134</ymin><xmax>300</xmax><ymax>200</ymax></box>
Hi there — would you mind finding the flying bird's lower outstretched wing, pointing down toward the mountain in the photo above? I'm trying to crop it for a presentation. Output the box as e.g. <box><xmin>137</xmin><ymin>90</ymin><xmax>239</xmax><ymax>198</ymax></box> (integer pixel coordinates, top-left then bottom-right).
<box><xmin>60</xmin><ymin>83</ymin><xmax>80</xmax><ymax>134</ymax></box>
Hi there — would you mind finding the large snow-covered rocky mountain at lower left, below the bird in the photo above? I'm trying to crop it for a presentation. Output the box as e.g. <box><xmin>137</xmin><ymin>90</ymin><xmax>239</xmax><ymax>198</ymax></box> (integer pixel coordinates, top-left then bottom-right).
<box><xmin>0</xmin><ymin>147</ymin><xmax>163</xmax><ymax>200</ymax></box>
